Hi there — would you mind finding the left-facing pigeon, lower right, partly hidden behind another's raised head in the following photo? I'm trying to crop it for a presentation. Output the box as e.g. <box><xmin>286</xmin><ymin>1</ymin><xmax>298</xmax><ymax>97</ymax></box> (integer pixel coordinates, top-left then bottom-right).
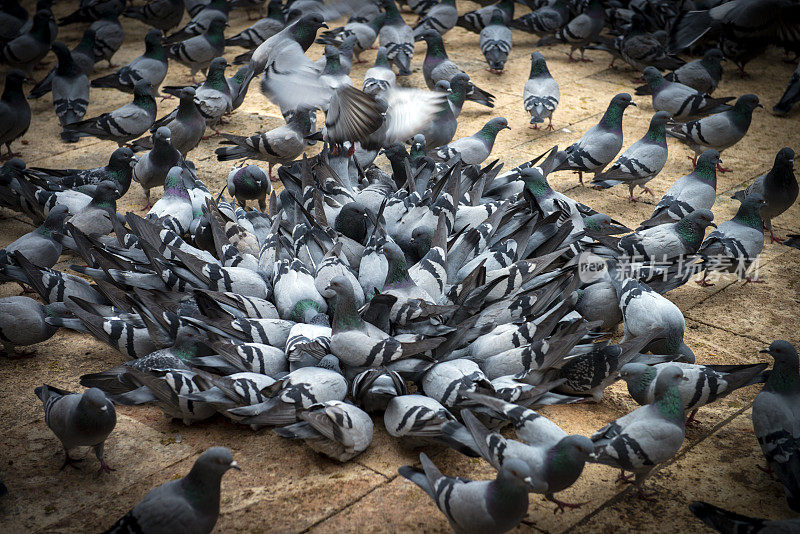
<box><xmin>619</xmin><ymin>362</ymin><xmax>767</xmax><ymax>423</ymax></box>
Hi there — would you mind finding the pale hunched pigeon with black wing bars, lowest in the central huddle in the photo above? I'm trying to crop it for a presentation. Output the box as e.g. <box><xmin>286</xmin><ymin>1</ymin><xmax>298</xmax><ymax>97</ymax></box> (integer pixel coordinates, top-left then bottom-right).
<box><xmin>275</xmin><ymin>400</ymin><xmax>372</xmax><ymax>462</ymax></box>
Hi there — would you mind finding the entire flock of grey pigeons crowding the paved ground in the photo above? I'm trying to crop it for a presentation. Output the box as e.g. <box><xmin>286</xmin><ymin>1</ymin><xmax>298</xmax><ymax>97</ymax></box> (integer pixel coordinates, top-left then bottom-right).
<box><xmin>0</xmin><ymin>0</ymin><xmax>800</xmax><ymax>534</ymax></box>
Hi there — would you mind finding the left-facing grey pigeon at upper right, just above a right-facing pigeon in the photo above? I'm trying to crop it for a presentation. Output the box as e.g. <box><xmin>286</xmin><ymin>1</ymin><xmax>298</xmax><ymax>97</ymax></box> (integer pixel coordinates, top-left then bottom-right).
<box><xmin>643</xmin><ymin>67</ymin><xmax>733</xmax><ymax>121</ymax></box>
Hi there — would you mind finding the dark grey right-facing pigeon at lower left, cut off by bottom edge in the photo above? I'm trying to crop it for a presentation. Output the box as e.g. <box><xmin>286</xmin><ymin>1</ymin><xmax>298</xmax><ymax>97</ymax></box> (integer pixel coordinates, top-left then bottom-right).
<box><xmin>101</xmin><ymin>447</ymin><xmax>241</xmax><ymax>534</ymax></box>
